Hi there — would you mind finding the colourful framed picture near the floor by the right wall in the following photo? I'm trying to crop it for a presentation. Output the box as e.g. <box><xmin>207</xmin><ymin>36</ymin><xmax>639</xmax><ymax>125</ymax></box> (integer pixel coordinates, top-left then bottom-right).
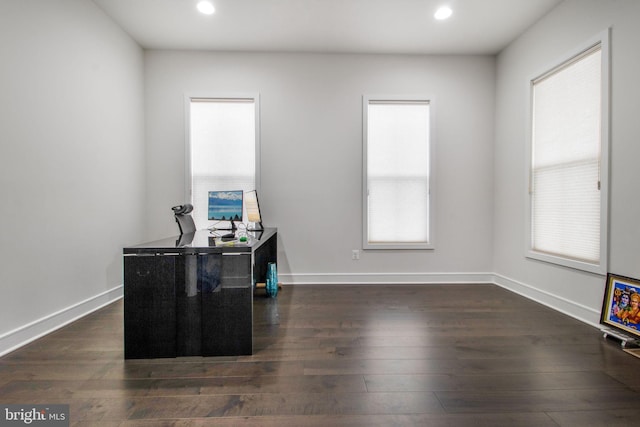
<box><xmin>600</xmin><ymin>273</ymin><xmax>640</xmax><ymax>338</ymax></box>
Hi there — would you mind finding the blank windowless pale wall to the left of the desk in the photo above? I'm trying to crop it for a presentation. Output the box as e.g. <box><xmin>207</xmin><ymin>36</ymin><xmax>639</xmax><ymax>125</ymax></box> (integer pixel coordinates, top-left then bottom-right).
<box><xmin>0</xmin><ymin>0</ymin><xmax>145</xmax><ymax>354</ymax></box>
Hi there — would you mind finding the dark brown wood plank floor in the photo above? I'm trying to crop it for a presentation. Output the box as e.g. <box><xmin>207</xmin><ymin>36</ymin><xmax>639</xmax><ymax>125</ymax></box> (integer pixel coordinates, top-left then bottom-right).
<box><xmin>0</xmin><ymin>285</ymin><xmax>640</xmax><ymax>427</ymax></box>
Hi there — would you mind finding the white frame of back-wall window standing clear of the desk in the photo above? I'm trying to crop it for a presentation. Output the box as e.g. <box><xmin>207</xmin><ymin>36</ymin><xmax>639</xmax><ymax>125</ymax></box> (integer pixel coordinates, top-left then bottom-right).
<box><xmin>362</xmin><ymin>94</ymin><xmax>435</xmax><ymax>250</ymax></box>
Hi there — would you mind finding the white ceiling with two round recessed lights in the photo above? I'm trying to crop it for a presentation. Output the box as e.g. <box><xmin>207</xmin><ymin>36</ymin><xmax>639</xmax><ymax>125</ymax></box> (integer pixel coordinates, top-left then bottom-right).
<box><xmin>93</xmin><ymin>0</ymin><xmax>562</xmax><ymax>54</ymax></box>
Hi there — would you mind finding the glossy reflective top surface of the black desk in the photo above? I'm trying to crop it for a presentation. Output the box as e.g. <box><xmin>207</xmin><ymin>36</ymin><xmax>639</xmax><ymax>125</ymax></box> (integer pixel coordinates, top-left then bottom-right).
<box><xmin>122</xmin><ymin>228</ymin><xmax>278</xmax><ymax>255</ymax></box>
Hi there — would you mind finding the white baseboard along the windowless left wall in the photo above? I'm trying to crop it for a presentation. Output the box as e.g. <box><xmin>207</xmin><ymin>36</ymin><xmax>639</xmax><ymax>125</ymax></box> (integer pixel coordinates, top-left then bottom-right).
<box><xmin>0</xmin><ymin>285</ymin><xmax>124</xmax><ymax>356</ymax></box>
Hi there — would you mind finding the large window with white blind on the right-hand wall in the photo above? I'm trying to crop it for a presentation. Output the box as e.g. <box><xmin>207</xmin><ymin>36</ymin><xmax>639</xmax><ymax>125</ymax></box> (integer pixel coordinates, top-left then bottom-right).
<box><xmin>528</xmin><ymin>31</ymin><xmax>609</xmax><ymax>274</ymax></box>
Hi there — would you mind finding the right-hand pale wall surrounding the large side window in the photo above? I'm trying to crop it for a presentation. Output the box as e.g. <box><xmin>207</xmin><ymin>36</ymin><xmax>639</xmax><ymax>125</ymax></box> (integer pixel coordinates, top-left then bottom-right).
<box><xmin>493</xmin><ymin>0</ymin><xmax>640</xmax><ymax>324</ymax></box>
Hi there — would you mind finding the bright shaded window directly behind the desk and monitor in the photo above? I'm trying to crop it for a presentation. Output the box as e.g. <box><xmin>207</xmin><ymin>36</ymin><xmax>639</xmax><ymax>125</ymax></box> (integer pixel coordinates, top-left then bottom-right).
<box><xmin>186</xmin><ymin>96</ymin><xmax>259</xmax><ymax>228</ymax></box>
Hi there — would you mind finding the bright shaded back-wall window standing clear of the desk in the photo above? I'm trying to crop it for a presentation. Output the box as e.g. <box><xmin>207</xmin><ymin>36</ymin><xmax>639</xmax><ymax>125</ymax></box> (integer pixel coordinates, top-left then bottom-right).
<box><xmin>363</xmin><ymin>97</ymin><xmax>433</xmax><ymax>249</ymax></box>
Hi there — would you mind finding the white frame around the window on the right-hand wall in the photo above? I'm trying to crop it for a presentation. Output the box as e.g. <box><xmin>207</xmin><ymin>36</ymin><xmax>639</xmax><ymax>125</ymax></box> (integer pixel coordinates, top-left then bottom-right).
<box><xmin>525</xmin><ymin>29</ymin><xmax>611</xmax><ymax>275</ymax></box>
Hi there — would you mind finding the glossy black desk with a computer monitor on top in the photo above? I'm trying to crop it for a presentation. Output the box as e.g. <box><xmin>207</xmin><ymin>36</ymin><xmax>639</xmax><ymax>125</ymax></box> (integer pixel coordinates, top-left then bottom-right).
<box><xmin>123</xmin><ymin>228</ymin><xmax>277</xmax><ymax>359</ymax></box>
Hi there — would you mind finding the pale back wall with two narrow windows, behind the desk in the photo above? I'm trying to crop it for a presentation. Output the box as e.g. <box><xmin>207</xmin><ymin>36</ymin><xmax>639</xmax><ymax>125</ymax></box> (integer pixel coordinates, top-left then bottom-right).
<box><xmin>145</xmin><ymin>51</ymin><xmax>495</xmax><ymax>283</ymax></box>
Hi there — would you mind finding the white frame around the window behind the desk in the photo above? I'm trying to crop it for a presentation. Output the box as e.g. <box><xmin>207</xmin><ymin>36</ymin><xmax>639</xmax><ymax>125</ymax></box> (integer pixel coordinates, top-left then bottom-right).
<box><xmin>184</xmin><ymin>93</ymin><xmax>261</xmax><ymax>227</ymax></box>
